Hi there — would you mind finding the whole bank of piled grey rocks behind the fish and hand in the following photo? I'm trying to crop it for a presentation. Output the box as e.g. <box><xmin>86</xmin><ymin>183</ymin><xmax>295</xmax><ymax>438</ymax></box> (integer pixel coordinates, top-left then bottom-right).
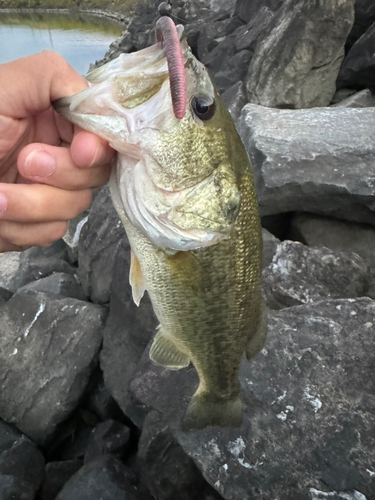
<box><xmin>0</xmin><ymin>0</ymin><xmax>375</xmax><ymax>500</ymax></box>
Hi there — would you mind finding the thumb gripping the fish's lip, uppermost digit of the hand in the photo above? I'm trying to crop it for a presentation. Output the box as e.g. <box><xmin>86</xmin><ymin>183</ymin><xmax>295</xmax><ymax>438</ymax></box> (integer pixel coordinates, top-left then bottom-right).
<box><xmin>0</xmin><ymin>50</ymin><xmax>88</xmax><ymax>118</ymax></box>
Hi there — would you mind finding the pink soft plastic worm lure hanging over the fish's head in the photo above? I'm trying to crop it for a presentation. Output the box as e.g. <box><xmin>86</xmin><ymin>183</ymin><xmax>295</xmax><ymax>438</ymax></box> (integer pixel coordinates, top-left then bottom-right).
<box><xmin>156</xmin><ymin>16</ymin><xmax>186</xmax><ymax>120</ymax></box>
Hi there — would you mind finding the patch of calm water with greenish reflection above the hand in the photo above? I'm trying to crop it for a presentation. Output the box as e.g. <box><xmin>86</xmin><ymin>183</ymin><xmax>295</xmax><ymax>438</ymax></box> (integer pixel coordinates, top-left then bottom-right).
<box><xmin>0</xmin><ymin>11</ymin><xmax>124</xmax><ymax>74</ymax></box>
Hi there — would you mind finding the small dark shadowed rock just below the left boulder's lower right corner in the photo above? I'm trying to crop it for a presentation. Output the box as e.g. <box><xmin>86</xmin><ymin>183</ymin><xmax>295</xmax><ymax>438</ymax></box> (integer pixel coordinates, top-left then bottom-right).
<box><xmin>84</xmin><ymin>420</ymin><xmax>130</xmax><ymax>464</ymax></box>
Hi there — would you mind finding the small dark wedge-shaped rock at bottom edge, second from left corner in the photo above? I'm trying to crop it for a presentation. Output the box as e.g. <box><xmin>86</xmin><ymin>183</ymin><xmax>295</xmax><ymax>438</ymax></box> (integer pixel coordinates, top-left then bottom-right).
<box><xmin>39</xmin><ymin>460</ymin><xmax>82</xmax><ymax>500</ymax></box>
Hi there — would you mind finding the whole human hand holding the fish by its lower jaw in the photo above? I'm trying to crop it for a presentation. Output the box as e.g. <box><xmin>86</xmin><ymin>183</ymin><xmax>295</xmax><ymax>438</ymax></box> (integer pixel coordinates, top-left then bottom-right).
<box><xmin>0</xmin><ymin>51</ymin><xmax>114</xmax><ymax>252</ymax></box>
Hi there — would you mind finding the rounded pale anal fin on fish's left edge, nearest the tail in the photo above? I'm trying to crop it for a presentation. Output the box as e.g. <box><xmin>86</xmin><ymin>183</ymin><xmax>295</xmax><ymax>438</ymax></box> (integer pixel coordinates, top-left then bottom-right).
<box><xmin>150</xmin><ymin>330</ymin><xmax>190</xmax><ymax>370</ymax></box>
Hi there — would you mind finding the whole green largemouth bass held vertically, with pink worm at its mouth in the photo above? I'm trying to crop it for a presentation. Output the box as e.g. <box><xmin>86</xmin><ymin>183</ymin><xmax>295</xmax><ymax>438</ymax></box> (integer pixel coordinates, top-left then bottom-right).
<box><xmin>54</xmin><ymin>17</ymin><xmax>267</xmax><ymax>430</ymax></box>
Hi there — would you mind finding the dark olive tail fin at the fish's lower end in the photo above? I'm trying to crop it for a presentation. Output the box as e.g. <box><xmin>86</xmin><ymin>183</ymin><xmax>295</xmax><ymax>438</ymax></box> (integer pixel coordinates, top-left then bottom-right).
<box><xmin>181</xmin><ymin>393</ymin><xmax>242</xmax><ymax>431</ymax></box>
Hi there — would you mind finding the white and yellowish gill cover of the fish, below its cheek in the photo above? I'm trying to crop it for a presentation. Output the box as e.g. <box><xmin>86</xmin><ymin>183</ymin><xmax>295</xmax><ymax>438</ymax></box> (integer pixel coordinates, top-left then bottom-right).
<box><xmin>110</xmin><ymin>154</ymin><xmax>240</xmax><ymax>251</ymax></box>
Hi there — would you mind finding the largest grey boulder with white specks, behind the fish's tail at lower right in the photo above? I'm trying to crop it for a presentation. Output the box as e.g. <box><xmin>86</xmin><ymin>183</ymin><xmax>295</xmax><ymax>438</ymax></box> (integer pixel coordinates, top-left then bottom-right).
<box><xmin>132</xmin><ymin>298</ymin><xmax>375</xmax><ymax>500</ymax></box>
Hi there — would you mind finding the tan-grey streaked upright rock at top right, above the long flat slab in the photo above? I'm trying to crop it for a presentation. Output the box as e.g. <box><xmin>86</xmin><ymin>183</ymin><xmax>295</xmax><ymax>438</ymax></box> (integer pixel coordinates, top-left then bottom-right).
<box><xmin>246</xmin><ymin>0</ymin><xmax>354</xmax><ymax>109</ymax></box>
